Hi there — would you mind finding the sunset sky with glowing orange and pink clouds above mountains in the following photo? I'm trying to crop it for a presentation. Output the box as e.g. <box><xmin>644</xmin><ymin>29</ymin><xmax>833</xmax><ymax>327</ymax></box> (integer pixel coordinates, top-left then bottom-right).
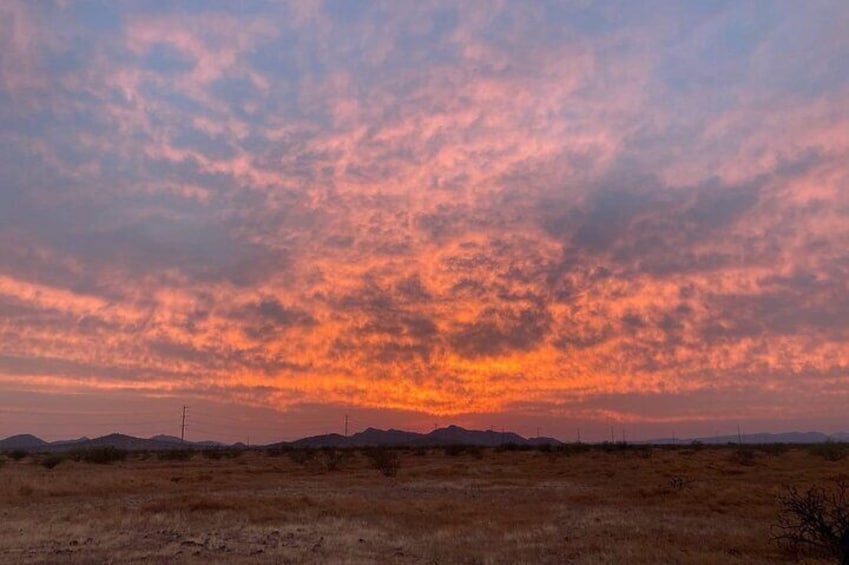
<box><xmin>0</xmin><ymin>0</ymin><xmax>849</xmax><ymax>442</ymax></box>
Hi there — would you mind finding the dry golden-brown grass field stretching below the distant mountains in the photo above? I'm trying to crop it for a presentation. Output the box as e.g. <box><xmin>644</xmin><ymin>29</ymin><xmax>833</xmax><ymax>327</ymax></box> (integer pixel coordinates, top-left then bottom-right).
<box><xmin>0</xmin><ymin>447</ymin><xmax>849</xmax><ymax>564</ymax></box>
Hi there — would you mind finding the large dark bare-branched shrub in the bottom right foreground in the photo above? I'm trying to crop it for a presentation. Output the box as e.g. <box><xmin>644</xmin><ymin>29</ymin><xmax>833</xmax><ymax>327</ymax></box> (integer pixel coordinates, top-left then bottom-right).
<box><xmin>773</xmin><ymin>480</ymin><xmax>849</xmax><ymax>565</ymax></box>
